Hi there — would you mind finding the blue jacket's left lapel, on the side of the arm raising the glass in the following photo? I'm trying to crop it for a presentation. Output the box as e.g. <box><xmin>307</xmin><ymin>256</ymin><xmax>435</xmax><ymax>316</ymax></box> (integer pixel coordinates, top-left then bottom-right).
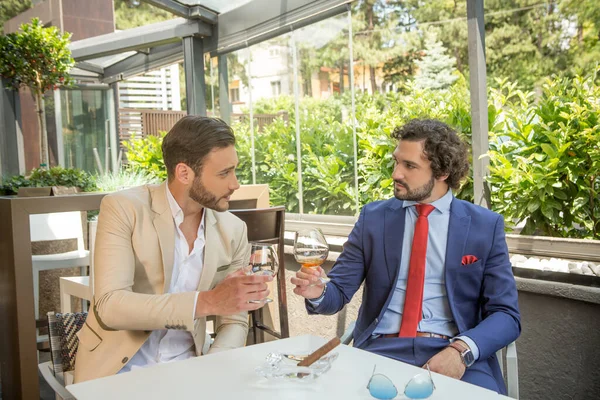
<box><xmin>383</xmin><ymin>201</ymin><xmax>406</xmax><ymax>282</ymax></box>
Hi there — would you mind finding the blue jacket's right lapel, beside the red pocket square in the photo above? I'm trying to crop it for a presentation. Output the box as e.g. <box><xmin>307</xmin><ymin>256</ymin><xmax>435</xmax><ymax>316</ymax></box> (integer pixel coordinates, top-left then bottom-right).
<box><xmin>444</xmin><ymin>198</ymin><xmax>471</xmax><ymax>314</ymax></box>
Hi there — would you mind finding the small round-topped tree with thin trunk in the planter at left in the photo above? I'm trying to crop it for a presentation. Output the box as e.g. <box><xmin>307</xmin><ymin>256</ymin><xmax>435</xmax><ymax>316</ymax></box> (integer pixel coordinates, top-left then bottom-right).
<box><xmin>0</xmin><ymin>18</ymin><xmax>75</xmax><ymax>168</ymax></box>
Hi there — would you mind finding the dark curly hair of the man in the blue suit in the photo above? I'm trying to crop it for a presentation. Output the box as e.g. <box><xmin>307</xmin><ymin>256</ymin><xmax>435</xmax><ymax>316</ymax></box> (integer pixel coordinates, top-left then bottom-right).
<box><xmin>392</xmin><ymin>119</ymin><xmax>469</xmax><ymax>189</ymax></box>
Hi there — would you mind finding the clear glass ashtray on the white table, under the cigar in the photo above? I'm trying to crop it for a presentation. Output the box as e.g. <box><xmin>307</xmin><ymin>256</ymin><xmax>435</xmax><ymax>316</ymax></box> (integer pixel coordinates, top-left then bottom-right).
<box><xmin>256</xmin><ymin>352</ymin><xmax>338</xmax><ymax>382</ymax></box>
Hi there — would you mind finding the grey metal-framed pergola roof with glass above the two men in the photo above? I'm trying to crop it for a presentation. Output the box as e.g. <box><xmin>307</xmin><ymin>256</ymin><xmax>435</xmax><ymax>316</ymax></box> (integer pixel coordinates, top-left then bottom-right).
<box><xmin>70</xmin><ymin>0</ymin><xmax>352</xmax><ymax>83</ymax></box>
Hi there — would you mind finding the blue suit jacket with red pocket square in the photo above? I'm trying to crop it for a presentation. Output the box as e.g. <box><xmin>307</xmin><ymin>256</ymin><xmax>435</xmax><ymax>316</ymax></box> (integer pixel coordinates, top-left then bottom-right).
<box><xmin>306</xmin><ymin>198</ymin><xmax>521</xmax><ymax>388</ymax></box>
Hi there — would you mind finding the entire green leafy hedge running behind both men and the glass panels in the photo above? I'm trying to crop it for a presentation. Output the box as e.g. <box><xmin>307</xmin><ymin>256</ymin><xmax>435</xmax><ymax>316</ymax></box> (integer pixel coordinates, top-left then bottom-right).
<box><xmin>119</xmin><ymin>70</ymin><xmax>600</xmax><ymax>239</ymax></box>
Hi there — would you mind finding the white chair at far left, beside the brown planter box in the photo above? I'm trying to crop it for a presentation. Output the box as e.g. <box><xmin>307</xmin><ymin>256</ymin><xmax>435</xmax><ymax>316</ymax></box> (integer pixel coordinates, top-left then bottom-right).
<box><xmin>29</xmin><ymin>211</ymin><xmax>90</xmax><ymax>342</ymax></box>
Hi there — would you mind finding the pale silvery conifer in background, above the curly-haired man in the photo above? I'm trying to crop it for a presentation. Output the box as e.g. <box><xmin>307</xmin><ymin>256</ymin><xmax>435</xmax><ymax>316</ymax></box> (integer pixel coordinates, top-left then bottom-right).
<box><xmin>415</xmin><ymin>33</ymin><xmax>457</xmax><ymax>89</ymax></box>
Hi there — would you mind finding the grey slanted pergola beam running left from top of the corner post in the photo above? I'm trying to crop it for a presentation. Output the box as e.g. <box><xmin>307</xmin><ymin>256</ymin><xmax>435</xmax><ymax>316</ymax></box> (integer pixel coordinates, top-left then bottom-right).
<box><xmin>70</xmin><ymin>18</ymin><xmax>212</xmax><ymax>61</ymax></box>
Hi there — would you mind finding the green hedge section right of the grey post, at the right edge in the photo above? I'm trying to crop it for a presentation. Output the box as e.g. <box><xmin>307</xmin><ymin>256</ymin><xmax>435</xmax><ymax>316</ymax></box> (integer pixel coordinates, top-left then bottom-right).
<box><xmin>489</xmin><ymin>69</ymin><xmax>600</xmax><ymax>239</ymax></box>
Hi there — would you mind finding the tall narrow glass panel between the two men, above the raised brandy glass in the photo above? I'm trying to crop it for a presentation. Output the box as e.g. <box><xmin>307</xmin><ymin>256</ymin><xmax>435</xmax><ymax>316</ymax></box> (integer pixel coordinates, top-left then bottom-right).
<box><xmin>294</xmin><ymin>13</ymin><xmax>356</xmax><ymax>215</ymax></box>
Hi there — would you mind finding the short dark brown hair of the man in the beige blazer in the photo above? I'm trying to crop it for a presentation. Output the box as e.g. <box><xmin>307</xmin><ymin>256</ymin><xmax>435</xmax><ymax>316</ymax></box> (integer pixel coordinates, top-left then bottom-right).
<box><xmin>162</xmin><ymin>115</ymin><xmax>235</xmax><ymax>180</ymax></box>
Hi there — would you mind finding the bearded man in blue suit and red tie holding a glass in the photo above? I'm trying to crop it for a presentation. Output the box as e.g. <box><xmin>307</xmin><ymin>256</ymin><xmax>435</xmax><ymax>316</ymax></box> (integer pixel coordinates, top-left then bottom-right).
<box><xmin>292</xmin><ymin>120</ymin><xmax>521</xmax><ymax>394</ymax></box>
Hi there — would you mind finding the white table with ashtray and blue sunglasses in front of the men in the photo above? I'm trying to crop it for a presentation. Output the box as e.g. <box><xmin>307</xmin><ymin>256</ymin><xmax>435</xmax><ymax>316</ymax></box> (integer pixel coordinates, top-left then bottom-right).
<box><xmin>67</xmin><ymin>335</ymin><xmax>501</xmax><ymax>400</ymax></box>
